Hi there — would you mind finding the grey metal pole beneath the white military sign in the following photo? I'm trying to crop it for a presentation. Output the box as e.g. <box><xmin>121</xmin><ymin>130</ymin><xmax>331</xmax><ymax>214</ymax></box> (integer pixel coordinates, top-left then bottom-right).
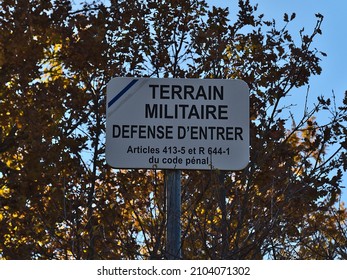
<box><xmin>165</xmin><ymin>169</ymin><xmax>181</xmax><ymax>260</ymax></box>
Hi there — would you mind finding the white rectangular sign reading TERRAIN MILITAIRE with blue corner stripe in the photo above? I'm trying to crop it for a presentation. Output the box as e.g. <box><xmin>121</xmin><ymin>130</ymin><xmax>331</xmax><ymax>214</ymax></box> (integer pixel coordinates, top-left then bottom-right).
<box><xmin>106</xmin><ymin>77</ymin><xmax>249</xmax><ymax>170</ymax></box>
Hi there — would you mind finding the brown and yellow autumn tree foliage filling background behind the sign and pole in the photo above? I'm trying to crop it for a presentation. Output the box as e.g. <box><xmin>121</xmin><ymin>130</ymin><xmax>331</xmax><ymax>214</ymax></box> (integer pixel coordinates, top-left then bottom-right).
<box><xmin>0</xmin><ymin>0</ymin><xmax>347</xmax><ymax>259</ymax></box>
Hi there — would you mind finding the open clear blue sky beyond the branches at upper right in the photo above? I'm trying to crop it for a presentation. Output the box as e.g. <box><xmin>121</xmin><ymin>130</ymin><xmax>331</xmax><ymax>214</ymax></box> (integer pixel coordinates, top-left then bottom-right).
<box><xmin>207</xmin><ymin>0</ymin><xmax>347</xmax><ymax>202</ymax></box>
